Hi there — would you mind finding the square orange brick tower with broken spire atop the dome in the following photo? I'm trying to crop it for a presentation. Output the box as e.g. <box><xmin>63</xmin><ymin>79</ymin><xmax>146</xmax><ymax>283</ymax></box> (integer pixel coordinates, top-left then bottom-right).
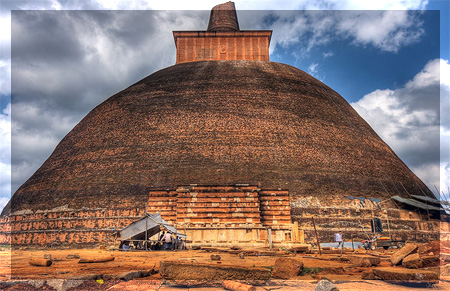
<box><xmin>173</xmin><ymin>2</ymin><xmax>272</xmax><ymax>64</ymax></box>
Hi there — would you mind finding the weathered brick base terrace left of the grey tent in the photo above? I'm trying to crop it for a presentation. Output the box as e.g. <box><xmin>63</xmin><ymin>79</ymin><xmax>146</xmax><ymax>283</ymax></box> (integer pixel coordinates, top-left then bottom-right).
<box><xmin>0</xmin><ymin>209</ymin><xmax>143</xmax><ymax>246</ymax></box>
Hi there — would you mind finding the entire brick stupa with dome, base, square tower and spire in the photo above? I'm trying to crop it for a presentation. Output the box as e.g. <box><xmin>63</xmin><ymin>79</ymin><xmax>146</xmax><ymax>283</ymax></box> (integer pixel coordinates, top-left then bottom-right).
<box><xmin>0</xmin><ymin>2</ymin><xmax>439</xmax><ymax>246</ymax></box>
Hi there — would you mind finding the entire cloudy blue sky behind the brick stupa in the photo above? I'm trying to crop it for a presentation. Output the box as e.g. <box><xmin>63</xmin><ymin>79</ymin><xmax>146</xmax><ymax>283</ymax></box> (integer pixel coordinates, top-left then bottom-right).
<box><xmin>0</xmin><ymin>0</ymin><xmax>450</xmax><ymax>214</ymax></box>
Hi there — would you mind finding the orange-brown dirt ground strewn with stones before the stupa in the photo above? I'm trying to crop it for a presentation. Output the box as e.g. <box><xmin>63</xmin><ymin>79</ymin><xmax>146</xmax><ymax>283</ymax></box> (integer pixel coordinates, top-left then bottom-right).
<box><xmin>0</xmin><ymin>249</ymin><xmax>450</xmax><ymax>291</ymax></box>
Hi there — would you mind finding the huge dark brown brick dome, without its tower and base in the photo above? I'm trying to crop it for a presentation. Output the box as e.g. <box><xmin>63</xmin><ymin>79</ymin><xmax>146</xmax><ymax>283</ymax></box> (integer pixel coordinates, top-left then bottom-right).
<box><xmin>5</xmin><ymin>61</ymin><xmax>430</xmax><ymax>216</ymax></box>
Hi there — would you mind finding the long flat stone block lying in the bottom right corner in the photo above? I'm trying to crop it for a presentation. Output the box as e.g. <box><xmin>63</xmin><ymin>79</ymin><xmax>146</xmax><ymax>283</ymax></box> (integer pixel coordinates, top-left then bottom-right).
<box><xmin>373</xmin><ymin>267</ymin><xmax>439</xmax><ymax>283</ymax></box>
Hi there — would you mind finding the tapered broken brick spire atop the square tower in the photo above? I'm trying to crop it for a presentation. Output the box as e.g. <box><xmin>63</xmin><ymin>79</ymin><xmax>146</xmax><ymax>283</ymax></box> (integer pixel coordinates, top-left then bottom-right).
<box><xmin>208</xmin><ymin>1</ymin><xmax>239</xmax><ymax>31</ymax></box>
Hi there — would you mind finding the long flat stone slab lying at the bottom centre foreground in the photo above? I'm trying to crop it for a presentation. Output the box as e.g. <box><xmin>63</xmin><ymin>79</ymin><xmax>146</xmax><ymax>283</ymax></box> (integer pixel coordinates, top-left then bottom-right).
<box><xmin>159</xmin><ymin>261</ymin><xmax>270</xmax><ymax>281</ymax></box>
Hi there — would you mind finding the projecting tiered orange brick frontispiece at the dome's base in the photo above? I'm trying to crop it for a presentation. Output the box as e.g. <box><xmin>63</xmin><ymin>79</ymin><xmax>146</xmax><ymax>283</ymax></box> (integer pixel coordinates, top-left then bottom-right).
<box><xmin>147</xmin><ymin>185</ymin><xmax>291</xmax><ymax>227</ymax></box>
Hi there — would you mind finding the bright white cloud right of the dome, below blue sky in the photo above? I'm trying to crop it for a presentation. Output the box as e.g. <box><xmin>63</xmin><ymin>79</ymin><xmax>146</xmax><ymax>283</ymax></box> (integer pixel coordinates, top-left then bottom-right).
<box><xmin>351</xmin><ymin>59</ymin><xmax>450</xmax><ymax>197</ymax></box>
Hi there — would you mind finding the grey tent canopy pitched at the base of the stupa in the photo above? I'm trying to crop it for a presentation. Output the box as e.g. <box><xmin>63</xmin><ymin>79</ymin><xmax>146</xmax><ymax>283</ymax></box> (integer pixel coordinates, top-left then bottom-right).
<box><xmin>119</xmin><ymin>213</ymin><xmax>186</xmax><ymax>240</ymax></box>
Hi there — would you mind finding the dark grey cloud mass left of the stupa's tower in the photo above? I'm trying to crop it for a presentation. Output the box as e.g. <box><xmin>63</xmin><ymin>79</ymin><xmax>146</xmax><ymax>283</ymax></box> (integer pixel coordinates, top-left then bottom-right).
<box><xmin>12</xmin><ymin>11</ymin><xmax>209</xmax><ymax>192</ymax></box>
